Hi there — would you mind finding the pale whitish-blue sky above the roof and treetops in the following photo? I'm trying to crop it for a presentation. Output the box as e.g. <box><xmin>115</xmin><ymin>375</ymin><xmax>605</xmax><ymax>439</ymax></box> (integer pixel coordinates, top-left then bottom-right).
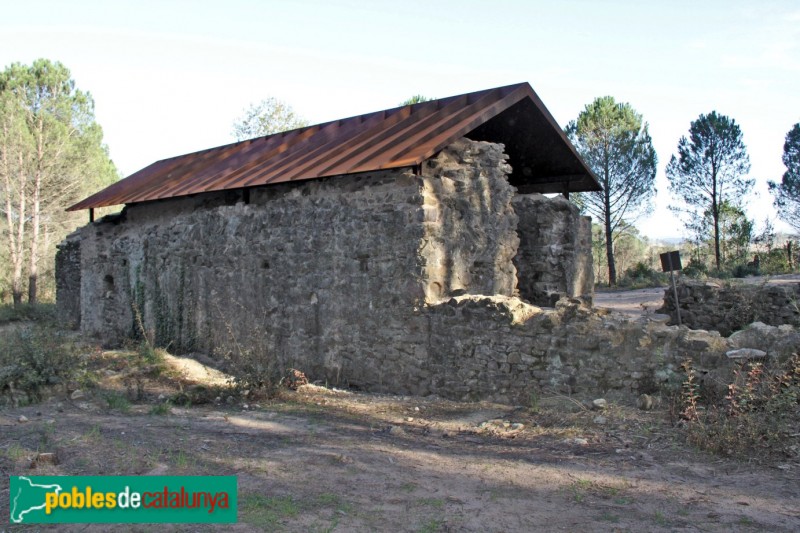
<box><xmin>0</xmin><ymin>0</ymin><xmax>800</xmax><ymax>237</ymax></box>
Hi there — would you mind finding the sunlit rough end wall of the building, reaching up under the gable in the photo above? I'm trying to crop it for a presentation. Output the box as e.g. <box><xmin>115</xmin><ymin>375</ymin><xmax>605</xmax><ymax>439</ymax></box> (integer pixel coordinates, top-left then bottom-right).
<box><xmin>420</xmin><ymin>139</ymin><xmax>520</xmax><ymax>303</ymax></box>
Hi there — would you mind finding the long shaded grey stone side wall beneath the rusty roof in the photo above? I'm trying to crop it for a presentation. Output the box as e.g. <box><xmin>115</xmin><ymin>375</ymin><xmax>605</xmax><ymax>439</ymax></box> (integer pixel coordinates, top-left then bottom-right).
<box><xmin>73</xmin><ymin>166</ymin><xmax>432</xmax><ymax>383</ymax></box>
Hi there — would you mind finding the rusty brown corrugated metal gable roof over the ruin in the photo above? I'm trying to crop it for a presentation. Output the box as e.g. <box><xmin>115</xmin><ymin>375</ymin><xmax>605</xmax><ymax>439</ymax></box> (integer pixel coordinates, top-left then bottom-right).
<box><xmin>68</xmin><ymin>83</ymin><xmax>600</xmax><ymax>211</ymax></box>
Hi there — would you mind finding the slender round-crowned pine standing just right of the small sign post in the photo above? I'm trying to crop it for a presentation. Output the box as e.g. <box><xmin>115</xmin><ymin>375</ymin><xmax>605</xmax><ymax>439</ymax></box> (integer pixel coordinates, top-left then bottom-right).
<box><xmin>667</xmin><ymin>111</ymin><xmax>753</xmax><ymax>270</ymax></box>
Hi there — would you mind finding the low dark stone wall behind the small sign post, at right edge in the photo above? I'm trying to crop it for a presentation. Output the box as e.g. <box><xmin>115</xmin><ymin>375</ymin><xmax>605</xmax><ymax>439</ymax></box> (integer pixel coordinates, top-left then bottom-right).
<box><xmin>659</xmin><ymin>280</ymin><xmax>800</xmax><ymax>336</ymax></box>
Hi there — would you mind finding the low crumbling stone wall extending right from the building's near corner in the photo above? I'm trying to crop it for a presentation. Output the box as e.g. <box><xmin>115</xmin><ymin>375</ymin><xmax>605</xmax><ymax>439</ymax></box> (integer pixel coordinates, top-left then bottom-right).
<box><xmin>418</xmin><ymin>296</ymin><xmax>800</xmax><ymax>404</ymax></box>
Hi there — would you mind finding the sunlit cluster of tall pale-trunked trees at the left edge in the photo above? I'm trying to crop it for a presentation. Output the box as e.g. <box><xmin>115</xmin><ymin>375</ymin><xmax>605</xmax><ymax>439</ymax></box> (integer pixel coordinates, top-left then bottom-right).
<box><xmin>0</xmin><ymin>59</ymin><xmax>118</xmax><ymax>305</ymax></box>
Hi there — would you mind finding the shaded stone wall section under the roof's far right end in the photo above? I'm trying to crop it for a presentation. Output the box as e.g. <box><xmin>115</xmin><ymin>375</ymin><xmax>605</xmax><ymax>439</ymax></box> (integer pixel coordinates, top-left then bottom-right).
<box><xmin>514</xmin><ymin>194</ymin><xmax>594</xmax><ymax>307</ymax></box>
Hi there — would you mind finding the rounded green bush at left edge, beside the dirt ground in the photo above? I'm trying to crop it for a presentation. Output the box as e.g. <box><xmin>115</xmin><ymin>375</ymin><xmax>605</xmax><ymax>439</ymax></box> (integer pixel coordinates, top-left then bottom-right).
<box><xmin>0</xmin><ymin>326</ymin><xmax>81</xmax><ymax>403</ymax></box>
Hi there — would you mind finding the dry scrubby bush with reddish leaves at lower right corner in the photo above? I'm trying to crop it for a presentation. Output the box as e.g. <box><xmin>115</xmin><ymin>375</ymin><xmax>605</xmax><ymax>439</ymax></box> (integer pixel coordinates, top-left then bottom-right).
<box><xmin>681</xmin><ymin>354</ymin><xmax>800</xmax><ymax>458</ymax></box>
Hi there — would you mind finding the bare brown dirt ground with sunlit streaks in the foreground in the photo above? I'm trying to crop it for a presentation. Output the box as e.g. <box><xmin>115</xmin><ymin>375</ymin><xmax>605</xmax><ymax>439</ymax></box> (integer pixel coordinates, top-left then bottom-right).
<box><xmin>0</xmin><ymin>352</ymin><xmax>800</xmax><ymax>532</ymax></box>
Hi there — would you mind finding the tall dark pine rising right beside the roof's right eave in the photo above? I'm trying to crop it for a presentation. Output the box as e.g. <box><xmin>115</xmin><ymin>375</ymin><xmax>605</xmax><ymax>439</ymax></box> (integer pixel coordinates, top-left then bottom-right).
<box><xmin>566</xmin><ymin>96</ymin><xmax>657</xmax><ymax>286</ymax></box>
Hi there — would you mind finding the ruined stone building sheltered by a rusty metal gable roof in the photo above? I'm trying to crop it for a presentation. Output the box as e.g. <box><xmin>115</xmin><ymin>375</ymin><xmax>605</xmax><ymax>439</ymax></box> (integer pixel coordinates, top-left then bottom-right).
<box><xmin>56</xmin><ymin>83</ymin><xmax>600</xmax><ymax>399</ymax></box>
